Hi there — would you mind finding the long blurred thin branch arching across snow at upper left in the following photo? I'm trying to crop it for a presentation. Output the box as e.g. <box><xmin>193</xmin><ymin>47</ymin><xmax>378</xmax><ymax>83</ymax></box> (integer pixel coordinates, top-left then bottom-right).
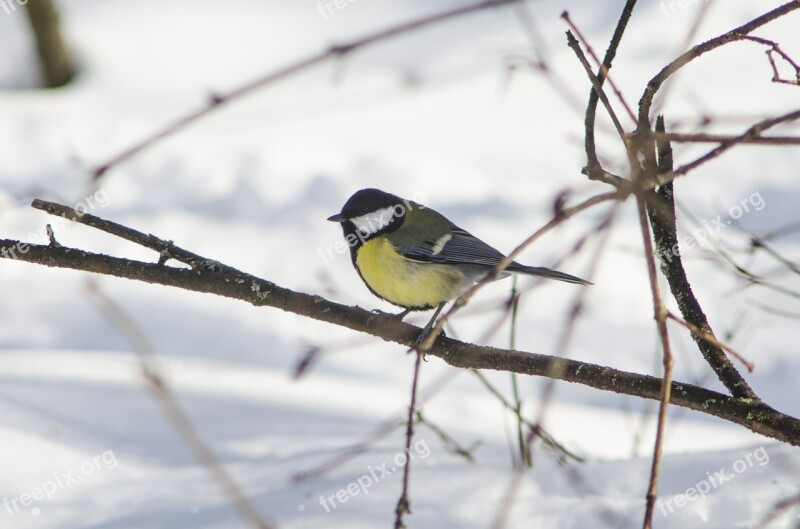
<box><xmin>92</xmin><ymin>0</ymin><xmax>519</xmax><ymax>181</ymax></box>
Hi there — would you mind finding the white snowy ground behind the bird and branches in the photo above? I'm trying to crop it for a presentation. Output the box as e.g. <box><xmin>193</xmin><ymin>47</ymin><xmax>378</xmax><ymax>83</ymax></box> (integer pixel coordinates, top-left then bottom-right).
<box><xmin>0</xmin><ymin>0</ymin><xmax>800</xmax><ymax>529</ymax></box>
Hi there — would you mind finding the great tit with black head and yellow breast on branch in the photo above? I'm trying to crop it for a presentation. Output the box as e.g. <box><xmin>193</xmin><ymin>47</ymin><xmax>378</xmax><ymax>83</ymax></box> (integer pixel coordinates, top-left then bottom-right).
<box><xmin>328</xmin><ymin>189</ymin><xmax>591</xmax><ymax>317</ymax></box>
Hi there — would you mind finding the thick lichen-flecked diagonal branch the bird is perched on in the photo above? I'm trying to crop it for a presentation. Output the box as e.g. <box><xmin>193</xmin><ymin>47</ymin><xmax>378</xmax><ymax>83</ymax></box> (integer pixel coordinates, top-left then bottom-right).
<box><xmin>0</xmin><ymin>201</ymin><xmax>800</xmax><ymax>446</ymax></box>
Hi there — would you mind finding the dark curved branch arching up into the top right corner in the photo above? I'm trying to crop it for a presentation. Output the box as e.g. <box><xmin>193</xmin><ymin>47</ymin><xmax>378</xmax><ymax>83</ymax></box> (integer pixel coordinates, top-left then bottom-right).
<box><xmin>636</xmin><ymin>0</ymin><xmax>800</xmax><ymax>128</ymax></box>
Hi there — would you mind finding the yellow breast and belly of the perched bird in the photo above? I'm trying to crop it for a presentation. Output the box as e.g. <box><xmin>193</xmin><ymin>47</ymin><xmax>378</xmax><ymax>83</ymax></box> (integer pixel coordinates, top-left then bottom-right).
<box><xmin>356</xmin><ymin>237</ymin><xmax>473</xmax><ymax>308</ymax></box>
